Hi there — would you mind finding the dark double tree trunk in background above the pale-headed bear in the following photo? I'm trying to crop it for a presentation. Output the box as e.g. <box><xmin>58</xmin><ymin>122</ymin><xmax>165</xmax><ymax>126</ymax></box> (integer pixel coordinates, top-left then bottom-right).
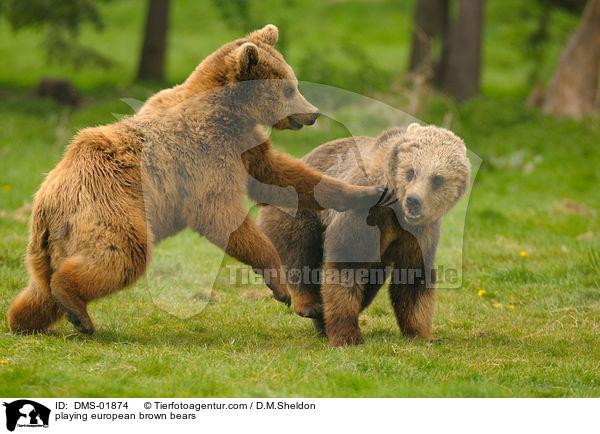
<box><xmin>410</xmin><ymin>0</ymin><xmax>484</xmax><ymax>101</ymax></box>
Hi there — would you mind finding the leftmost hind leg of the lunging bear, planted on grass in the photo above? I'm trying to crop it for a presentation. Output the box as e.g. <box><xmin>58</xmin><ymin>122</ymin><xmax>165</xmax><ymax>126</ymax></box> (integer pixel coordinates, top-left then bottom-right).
<box><xmin>7</xmin><ymin>214</ymin><xmax>63</xmax><ymax>333</ymax></box>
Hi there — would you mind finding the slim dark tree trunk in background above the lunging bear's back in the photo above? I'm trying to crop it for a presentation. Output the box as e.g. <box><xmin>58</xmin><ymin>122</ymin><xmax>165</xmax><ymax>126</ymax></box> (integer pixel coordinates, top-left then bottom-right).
<box><xmin>137</xmin><ymin>0</ymin><xmax>169</xmax><ymax>81</ymax></box>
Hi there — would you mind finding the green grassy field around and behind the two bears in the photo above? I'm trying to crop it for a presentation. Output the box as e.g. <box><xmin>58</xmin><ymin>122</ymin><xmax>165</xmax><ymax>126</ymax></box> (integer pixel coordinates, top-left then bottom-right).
<box><xmin>0</xmin><ymin>0</ymin><xmax>600</xmax><ymax>397</ymax></box>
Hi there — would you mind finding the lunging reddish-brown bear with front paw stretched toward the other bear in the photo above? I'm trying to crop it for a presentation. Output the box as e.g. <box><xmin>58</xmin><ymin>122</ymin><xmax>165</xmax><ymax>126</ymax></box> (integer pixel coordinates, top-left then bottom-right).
<box><xmin>8</xmin><ymin>25</ymin><xmax>385</xmax><ymax>334</ymax></box>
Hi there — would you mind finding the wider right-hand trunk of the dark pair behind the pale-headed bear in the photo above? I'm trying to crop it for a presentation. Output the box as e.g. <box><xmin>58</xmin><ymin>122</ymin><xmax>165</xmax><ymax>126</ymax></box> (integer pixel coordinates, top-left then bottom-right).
<box><xmin>438</xmin><ymin>0</ymin><xmax>484</xmax><ymax>101</ymax></box>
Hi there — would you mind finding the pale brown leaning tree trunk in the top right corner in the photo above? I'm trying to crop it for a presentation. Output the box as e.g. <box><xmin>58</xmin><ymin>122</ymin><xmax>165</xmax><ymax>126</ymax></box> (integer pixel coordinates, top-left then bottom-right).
<box><xmin>536</xmin><ymin>0</ymin><xmax>600</xmax><ymax>119</ymax></box>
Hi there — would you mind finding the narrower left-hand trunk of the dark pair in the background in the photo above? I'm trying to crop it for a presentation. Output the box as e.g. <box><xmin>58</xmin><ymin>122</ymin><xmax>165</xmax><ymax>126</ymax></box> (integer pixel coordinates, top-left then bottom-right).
<box><xmin>409</xmin><ymin>0</ymin><xmax>449</xmax><ymax>74</ymax></box>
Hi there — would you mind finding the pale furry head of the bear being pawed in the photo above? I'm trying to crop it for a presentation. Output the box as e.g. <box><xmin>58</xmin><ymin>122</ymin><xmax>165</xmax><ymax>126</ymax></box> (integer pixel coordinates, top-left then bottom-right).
<box><xmin>377</xmin><ymin>124</ymin><xmax>471</xmax><ymax>226</ymax></box>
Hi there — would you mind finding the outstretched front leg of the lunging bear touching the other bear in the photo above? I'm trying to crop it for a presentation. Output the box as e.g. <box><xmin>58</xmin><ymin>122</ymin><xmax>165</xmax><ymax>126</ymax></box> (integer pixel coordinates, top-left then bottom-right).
<box><xmin>242</xmin><ymin>143</ymin><xmax>387</xmax><ymax>211</ymax></box>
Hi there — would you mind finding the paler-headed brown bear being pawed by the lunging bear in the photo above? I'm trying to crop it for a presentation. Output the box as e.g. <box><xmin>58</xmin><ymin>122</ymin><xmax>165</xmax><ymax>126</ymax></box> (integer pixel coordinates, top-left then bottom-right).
<box><xmin>258</xmin><ymin>124</ymin><xmax>470</xmax><ymax>346</ymax></box>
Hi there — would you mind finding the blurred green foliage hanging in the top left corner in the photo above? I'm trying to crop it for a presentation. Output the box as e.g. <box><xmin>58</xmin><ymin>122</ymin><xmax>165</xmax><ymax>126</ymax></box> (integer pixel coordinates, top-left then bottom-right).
<box><xmin>0</xmin><ymin>0</ymin><xmax>111</xmax><ymax>68</ymax></box>
